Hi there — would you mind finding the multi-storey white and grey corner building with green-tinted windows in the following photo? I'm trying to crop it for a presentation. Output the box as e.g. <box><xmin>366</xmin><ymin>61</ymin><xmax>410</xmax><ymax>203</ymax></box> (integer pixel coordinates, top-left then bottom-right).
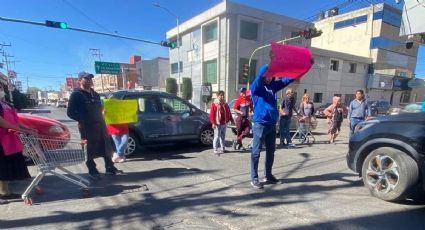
<box><xmin>167</xmin><ymin>1</ymin><xmax>310</xmax><ymax>108</ymax></box>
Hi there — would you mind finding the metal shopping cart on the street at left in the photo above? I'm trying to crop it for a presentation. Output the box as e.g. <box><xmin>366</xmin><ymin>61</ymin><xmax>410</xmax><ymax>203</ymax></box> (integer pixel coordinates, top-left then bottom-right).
<box><xmin>17</xmin><ymin>133</ymin><xmax>90</xmax><ymax>205</ymax></box>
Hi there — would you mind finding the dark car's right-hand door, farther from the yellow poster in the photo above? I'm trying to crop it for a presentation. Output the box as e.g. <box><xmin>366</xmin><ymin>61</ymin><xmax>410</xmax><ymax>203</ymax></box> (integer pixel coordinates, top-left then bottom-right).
<box><xmin>159</xmin><ymin>96</ymin><xmax>201</xmax><ymax>140</ymax></box>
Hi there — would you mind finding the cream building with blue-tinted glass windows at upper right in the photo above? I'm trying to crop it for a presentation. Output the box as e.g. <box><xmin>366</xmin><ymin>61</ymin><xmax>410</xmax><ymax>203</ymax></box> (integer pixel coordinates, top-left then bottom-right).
<box><xmin>311</xmin><ymin>4</ymin><xmax>418</xmax><ymax>105</ymax></box>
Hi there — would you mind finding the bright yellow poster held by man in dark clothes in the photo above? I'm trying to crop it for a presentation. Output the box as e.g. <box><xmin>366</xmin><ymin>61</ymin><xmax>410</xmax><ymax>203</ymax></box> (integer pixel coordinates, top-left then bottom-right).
<box><xmin>103</xmin><ymin>99</ymin><xmax>137</xmax><ymax>125</ymax></box>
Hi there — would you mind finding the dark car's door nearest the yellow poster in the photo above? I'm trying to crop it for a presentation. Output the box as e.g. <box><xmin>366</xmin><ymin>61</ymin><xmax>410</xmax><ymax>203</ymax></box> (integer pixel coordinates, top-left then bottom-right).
<box><xmin>124</xmin><ymin>95</ymin><xmax>165</xmax><ymax>140</ymax></box>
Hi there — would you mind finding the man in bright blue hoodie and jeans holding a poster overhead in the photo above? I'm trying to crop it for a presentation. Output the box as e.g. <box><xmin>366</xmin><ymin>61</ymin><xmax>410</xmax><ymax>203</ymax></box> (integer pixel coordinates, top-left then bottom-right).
<box><xmin>250</xmin><ymin>56</ymin><xmax>294</xmax><ymax>189</ymax></box>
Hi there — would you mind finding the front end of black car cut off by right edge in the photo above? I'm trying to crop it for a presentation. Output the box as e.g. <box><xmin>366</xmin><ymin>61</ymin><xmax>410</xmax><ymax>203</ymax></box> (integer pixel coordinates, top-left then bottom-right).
<box><xmin>347</xmin><ymin>112</ymin><xmax>425</xmax><ymax>201</ymax></box>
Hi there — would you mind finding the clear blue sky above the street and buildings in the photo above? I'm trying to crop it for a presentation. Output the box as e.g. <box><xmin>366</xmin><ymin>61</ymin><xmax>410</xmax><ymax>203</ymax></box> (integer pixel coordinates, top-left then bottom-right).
<box><xmin>0</xmin><ymin>0</ymin><xmax>425</xmax><ymax>91</ymax></box>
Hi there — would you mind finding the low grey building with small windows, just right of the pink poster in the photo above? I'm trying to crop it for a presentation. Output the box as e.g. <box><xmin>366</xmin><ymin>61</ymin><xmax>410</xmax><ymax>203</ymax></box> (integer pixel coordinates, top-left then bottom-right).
<box><xmin>292</xmin><ymin>48</ymin><xmax>372</xmax><ymax>106</ymax></box>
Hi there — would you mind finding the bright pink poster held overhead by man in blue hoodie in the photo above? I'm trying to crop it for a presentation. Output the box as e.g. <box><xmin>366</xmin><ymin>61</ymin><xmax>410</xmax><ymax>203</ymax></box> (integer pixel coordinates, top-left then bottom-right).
<box><xmin>264</xmin><ymin>42</ymin><xmax>313</xmax><ymax>79</ymax></box>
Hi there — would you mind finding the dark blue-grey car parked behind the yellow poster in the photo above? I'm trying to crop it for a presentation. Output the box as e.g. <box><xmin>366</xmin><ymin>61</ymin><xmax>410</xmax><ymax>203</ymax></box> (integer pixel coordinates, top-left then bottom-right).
<box><xmin>107</xmin><ymin>91</ymin><xmax>214</xmax><ymax>156</ymax></box>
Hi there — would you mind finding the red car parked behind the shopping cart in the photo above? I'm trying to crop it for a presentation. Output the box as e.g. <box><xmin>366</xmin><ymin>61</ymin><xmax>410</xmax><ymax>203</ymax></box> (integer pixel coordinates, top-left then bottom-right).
<box><xmin>18</xmin><ymin>113</ymin><xmax>71</xmax><ymax>149</ymax></box>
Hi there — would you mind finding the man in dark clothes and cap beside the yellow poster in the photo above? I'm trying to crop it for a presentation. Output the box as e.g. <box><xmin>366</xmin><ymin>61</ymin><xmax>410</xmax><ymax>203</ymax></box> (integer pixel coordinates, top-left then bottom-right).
<box><xmin>67</xmin><ymin>72</ymin><xmax>122</xmax><ymax>181</ymax></box>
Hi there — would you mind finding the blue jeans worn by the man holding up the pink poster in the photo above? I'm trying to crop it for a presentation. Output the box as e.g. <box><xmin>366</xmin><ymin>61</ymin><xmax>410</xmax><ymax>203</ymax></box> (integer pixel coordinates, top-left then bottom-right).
<box><xmin>251</xmin><ymin>123</ymin><xmax>276</xmax><ymax>181</ymax></box>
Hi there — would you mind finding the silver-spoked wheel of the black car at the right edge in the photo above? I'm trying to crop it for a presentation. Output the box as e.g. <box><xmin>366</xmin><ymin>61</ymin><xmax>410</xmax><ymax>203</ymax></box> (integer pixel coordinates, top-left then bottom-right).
<box><xmin>362</xmin><ymin>147</ymin><xmax>419</xmax><ymax>201</ymax></box>
